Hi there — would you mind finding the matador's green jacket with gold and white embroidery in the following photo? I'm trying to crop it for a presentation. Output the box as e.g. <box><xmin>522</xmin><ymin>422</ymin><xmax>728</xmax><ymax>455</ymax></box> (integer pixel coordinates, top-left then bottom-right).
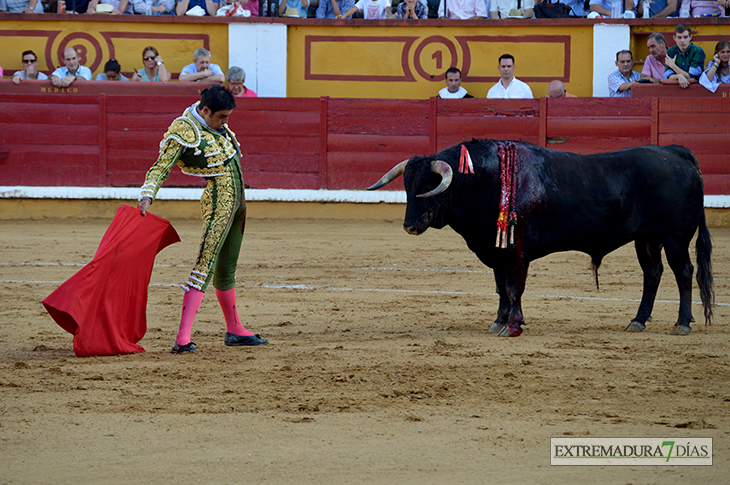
<box><xmin>140</xmin><ymin>103</ymin><xmax>240</xmax><ymax>201</ymax></box>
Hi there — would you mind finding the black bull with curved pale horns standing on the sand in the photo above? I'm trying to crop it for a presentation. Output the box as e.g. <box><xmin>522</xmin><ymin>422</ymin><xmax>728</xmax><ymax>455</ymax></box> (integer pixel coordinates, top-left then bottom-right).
<box><xmin>368</xmin><ymin>140</ymin><xmax>714</xmax><ymax>336</ymax></box>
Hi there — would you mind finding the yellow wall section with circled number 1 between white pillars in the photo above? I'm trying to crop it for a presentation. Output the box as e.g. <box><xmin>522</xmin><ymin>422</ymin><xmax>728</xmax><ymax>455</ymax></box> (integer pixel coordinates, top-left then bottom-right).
<box><xmin>287</xmin><ymin>22</ymin><xmax>593</xmax><ymax>99</ymax></box>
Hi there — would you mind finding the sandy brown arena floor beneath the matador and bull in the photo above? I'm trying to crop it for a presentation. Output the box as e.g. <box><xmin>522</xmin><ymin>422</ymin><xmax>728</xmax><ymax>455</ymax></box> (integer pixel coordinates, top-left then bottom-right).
<box><xmin>0</xmin><ymin>216</ymin><xmax>730</xmax><ymax>485</ymax></box>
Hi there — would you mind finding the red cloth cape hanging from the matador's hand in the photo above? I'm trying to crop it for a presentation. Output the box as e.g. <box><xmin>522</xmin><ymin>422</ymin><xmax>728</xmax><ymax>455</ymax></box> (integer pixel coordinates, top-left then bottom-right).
<box><xmin>43</xmin><ymin>205</ymin><xmax>180</xmax><ymax>357</ymax></box>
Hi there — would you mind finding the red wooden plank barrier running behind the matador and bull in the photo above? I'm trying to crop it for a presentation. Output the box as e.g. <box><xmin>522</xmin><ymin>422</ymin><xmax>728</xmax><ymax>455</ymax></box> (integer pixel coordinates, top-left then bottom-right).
<box><xmin>0</xmin><ymin>91</ymin><xmax>730</xmax><ymax>194</ymax></box>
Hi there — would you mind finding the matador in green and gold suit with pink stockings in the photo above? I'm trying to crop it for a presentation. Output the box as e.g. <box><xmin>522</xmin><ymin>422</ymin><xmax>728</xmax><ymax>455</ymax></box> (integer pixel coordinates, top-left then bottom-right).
<box><xmin>139</xmin><ymin>84</ymin><xmax>267</xmax><ymax>354</ymax></box>
